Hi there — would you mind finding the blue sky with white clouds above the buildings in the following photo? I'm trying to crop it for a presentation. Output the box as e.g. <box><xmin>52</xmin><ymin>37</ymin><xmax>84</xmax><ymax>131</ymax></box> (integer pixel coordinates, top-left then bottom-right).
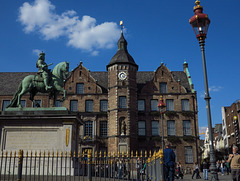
<box><xmin>0</xmin><ymin>0</ymin><xmax>240</xmax><ymax>139</ymax></box>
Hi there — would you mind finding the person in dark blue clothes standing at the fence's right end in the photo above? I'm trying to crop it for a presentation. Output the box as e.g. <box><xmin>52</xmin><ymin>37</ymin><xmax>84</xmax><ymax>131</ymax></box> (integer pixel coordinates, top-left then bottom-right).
<box><xmin>163</xmin><ymin>142</ymin><xmax>175</xmax><ymax>181</ymax></box>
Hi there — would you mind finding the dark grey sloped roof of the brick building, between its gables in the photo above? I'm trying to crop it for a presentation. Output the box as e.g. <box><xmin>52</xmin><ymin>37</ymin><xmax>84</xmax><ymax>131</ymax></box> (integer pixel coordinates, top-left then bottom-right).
<box><xmin>0</xmin><ymin>71</ymin><xmax>191</xmax><ymax>95</ymax></box>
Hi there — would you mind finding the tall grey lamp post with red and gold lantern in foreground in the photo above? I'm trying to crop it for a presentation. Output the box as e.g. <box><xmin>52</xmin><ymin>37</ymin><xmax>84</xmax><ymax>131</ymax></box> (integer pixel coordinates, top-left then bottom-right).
<box><xmin>189</xmin><ymin>0</ymin><xmax>218</xmax><ymax>181</ymax></box>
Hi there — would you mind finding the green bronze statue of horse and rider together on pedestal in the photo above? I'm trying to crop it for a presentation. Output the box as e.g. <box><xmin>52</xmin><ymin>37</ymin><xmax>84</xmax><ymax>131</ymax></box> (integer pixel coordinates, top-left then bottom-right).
<box><xmin>7</xmin><ymin>52</ymin><xmax>69</xmax><ymax>108</ymax></box>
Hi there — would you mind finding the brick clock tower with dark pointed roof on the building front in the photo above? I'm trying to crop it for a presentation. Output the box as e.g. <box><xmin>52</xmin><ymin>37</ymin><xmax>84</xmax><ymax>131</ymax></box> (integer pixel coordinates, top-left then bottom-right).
<box><xmin>107</xmin><ymin>27</ymin><xmax>138</xmax><ymax>153</ymax></box>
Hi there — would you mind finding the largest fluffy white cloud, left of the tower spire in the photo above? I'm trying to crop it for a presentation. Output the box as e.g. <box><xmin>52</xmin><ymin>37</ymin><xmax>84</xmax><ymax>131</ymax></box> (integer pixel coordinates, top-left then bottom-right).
<box><xmin>19</xmin><ymin>0</ymin><xmax>120</xmax><ymax>56</ymax></box>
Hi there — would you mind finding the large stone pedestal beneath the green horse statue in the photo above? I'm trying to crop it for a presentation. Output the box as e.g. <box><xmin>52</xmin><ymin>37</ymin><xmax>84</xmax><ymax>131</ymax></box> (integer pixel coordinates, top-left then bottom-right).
<box><xmin>0</xmin><ymin>108</ymin><xmax>82</xmax><ymax>152</ymax></box>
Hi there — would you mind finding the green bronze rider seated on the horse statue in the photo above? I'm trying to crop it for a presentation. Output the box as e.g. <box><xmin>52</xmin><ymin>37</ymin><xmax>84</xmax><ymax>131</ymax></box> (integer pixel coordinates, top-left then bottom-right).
<box><xmin>36</xmin><ymin>52</ymin><xmax>52</xmax><ymax>91</ymax></box>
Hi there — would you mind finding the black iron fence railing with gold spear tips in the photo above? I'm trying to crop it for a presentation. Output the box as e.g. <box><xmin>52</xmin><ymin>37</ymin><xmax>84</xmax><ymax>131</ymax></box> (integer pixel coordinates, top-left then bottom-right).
<box><xmin>0</xmin><ymin>150</ymin><xmax>164</xmax><ymax>181</ymax></box>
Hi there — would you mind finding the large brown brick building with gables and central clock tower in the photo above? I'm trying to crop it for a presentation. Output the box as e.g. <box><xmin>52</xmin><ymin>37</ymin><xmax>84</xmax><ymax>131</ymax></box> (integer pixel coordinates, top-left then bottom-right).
<box><xmin>0</xmin><ymin>33</ymin><xmax>199</xmax><ymax>165</ymax></box>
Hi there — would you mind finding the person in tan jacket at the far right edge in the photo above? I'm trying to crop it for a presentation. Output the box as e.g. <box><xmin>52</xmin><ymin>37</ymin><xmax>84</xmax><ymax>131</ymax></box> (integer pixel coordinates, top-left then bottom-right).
<box><xmin>227</xmin><ymin>146</ymin><xmax>240</xmax><ymax>181</ymax></box>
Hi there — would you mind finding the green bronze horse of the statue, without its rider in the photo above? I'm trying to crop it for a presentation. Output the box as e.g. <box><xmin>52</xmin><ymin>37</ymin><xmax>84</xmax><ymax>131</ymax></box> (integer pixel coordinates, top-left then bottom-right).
<box><xmin>7</xmin><ymin>62</ymin><xmax>69</xmax><ymax>108</ymax></box>
